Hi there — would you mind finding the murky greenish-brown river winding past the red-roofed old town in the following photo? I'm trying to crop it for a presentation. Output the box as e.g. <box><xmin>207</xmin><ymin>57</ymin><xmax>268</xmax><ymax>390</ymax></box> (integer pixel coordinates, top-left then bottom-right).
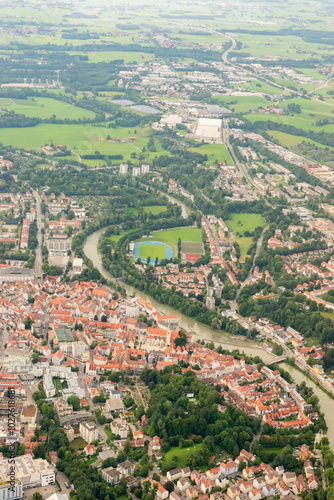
<box><xmin>83</xmin><ymin>195</ymin><xmax>334</xmax><ymax>449</ymax></box>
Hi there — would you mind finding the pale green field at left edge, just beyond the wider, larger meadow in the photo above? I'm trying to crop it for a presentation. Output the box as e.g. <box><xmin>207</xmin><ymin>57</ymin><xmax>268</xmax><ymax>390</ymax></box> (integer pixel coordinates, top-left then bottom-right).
<box><xmin>0</xmin><ymin>97</ymin><xmax>95</xmax><ymax>120</ymax></box>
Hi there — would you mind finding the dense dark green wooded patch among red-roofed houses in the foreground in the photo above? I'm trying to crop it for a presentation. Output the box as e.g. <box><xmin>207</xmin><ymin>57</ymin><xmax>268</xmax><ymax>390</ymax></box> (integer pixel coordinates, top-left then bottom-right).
<box><xmin>141</xmin><ymin>366</ymin><xmax>260</xmax><ymax>468</ymax></box>
